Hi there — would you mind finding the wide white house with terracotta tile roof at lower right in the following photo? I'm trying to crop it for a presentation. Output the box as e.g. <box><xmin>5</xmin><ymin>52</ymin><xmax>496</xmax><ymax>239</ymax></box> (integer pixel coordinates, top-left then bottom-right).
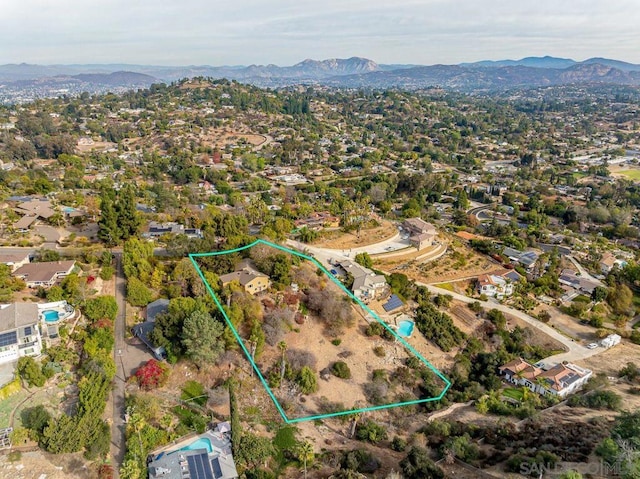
<box><xmin>498</xmin><ymin>358</ymin><xmax>593</xmax><ymax>398</ymax></box>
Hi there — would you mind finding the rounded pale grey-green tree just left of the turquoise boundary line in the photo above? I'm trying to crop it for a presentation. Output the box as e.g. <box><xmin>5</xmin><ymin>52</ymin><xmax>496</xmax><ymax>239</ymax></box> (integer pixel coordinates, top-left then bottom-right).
<box><xmin>182</xmin><ymin>311</ymin><xmax>224</xmax><ymax>365</ymax></box>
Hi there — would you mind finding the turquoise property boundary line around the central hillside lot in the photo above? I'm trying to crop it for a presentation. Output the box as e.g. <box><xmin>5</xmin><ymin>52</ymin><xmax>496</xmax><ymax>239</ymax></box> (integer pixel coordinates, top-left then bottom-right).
<box><xmin>189</xmin><ymin>239</ymin><xmax>451</xmax><ymax>424</ymax></box>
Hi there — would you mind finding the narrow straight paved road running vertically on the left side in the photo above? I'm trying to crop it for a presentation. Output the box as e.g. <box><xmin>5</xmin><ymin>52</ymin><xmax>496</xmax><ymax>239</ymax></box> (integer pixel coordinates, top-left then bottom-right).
<box><xmin>111</xmin><ymin>253</ymin><xmax>127</xmax><ymax>479</ymax></box>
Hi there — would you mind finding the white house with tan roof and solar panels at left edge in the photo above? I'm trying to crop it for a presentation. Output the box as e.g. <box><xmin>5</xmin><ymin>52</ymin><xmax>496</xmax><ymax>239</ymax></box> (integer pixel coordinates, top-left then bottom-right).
<box><xmin>0</xmin><ymin>303</ymin><xmax>42</xmax><ymax>364</ymax></box>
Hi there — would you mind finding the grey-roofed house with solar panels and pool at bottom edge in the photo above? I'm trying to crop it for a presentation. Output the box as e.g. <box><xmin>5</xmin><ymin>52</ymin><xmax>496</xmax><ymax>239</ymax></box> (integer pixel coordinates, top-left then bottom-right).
<box><xmin>148</xmin><ymin>422</ymin><xmax>238</xmax><ymax>479</ymax></box>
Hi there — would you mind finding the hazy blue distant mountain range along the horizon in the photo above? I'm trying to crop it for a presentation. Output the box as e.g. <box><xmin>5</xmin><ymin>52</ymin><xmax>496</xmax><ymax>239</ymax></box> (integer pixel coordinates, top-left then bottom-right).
<box><xmin>0</xmin><ymin>56</ymin><xmax>640</xmax><ymax>99</ymax></box>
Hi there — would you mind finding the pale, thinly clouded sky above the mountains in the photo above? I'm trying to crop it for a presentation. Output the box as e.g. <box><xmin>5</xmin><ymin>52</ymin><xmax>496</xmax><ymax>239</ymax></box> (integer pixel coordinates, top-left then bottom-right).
<box><xmin>0</xmin><ymin>0</ymin><xmax>640</xmax><ymax>65</ymax></box>
